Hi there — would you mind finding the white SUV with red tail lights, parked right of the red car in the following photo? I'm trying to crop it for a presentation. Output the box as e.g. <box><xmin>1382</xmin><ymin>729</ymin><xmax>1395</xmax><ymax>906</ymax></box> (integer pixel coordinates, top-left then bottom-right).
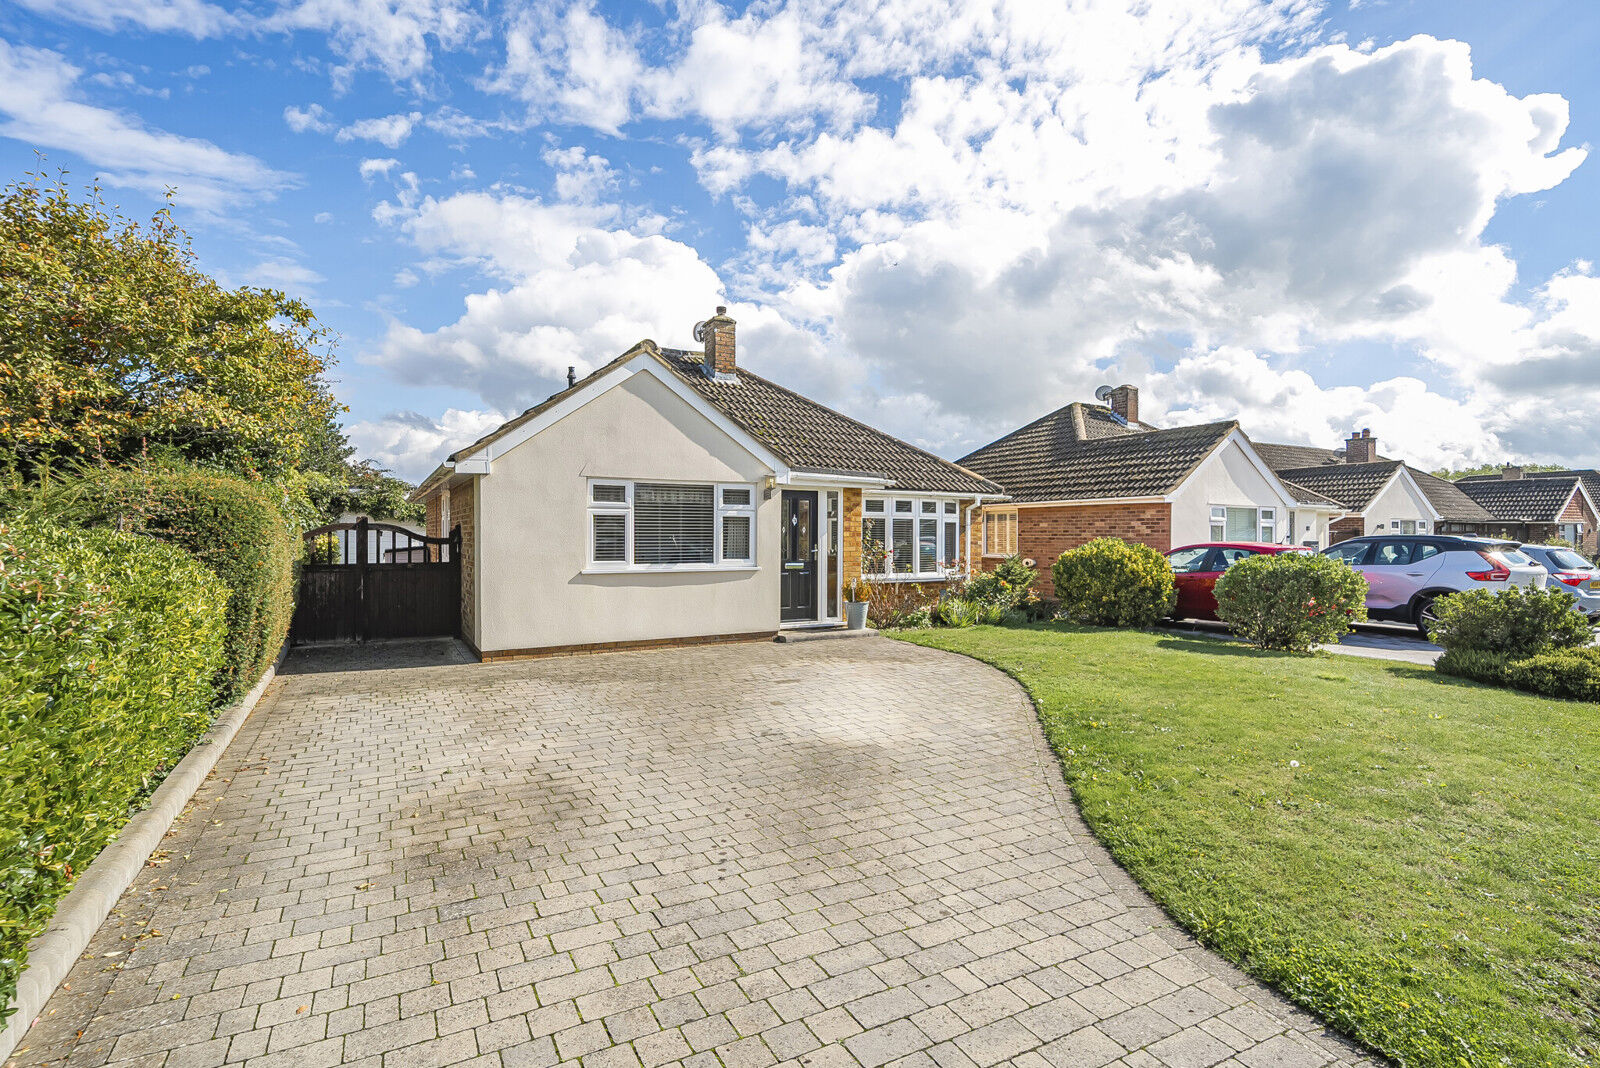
<box><xmin>1322</xmin><ymin>534</ymin><xmax>1550</xmax><ymax>638</ymax></box>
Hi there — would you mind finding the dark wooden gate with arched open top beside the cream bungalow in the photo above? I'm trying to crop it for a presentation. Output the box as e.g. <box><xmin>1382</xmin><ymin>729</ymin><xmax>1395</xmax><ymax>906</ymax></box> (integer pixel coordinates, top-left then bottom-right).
<box><xmin>293</xmin><ymin>518</ymin><xmax>461</xmax><ymax>644</ymax></box>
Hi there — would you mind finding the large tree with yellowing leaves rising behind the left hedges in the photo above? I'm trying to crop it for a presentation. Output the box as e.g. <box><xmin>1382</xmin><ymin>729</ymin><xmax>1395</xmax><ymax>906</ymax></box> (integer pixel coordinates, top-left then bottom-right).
<box><xmin>0</xmin><ymin>174</ymin><xmax>339</xmax><ymax>478</ymax></box>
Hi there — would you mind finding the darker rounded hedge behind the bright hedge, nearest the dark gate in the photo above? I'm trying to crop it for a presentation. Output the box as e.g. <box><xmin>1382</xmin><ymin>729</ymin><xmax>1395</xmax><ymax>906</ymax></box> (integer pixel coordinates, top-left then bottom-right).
<box><xmin>53</xmin><ymin>464</ymin><xmax>298</xmax><ymax>702</ymax></box>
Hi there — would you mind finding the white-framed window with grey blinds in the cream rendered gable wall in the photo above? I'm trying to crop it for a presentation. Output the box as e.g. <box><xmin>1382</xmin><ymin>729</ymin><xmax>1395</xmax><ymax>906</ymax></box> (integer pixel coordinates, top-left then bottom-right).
<box><xmin>589</xmin><ymin>481</ymin><xmax>755</xmax><ymax>571</ymax></box>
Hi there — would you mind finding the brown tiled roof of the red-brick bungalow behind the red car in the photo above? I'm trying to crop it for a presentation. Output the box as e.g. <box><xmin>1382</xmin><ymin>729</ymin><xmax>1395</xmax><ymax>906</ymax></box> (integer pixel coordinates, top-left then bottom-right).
<box><xmin>960</xmin><ymin>404</ymin><xmax>1238</xmax><ymax>502</ymax></box>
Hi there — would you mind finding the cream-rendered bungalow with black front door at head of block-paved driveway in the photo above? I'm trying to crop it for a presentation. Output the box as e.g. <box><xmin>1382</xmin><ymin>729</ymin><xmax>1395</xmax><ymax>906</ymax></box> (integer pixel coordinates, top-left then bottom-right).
<box><xmin>413</xmin><ymin>309</ymin><xmax>1003</xmax><ymax>660</ymax></box>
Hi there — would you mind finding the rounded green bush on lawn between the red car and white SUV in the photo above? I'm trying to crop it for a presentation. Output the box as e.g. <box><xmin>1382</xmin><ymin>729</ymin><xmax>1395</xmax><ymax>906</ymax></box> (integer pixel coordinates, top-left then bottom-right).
<box><xmin>1216</xmin><ymin>553</ymin><xmax>1366</xmax><ymax>652</ymax></box>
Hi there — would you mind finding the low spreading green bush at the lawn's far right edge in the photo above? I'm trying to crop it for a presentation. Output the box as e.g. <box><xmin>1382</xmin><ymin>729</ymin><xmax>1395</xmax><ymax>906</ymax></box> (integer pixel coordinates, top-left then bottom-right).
<box><xmin>1429</xmin><ymin>587</ymin><xmax>1594</xmax><ymax>659</ymax></box>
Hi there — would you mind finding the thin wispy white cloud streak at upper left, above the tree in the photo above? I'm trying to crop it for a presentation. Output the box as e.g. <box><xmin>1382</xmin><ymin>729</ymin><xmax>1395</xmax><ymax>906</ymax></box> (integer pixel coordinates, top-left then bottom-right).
<box><xmin>0</xmin><ymin>40</ymin><xmax>299</xmax><ymax>213</ymax></box>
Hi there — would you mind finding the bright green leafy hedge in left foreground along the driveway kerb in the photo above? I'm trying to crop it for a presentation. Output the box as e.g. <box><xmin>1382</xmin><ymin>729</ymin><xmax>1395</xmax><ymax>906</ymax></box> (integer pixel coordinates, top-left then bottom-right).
<box><xmin>0</xmin><ymin>521</ymin><xmax>227</xmax><ymax>1018</ymax></box>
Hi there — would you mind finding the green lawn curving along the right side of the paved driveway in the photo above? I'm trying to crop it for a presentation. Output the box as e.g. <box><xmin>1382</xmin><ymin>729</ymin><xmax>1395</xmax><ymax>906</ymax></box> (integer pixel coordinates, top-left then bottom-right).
<box><xmin>899</xmin><ymin>625</ymin><xmax>1600</xmax><ymax>1066</ymax></box>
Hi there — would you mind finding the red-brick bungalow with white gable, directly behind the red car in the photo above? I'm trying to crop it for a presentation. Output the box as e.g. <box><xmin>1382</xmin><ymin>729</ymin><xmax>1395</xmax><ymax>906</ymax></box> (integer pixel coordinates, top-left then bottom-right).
<box><xmin>960</xmin><ymin>385</ymin><xmax>1347</xmax><ymax>596</ymax></box>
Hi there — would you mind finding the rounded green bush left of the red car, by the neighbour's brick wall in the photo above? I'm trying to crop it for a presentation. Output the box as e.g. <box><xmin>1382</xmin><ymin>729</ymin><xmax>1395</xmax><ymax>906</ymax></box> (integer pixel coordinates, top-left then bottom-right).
<box><xmin>1051</xmin><ymin>537</ymin><xmax>1178</xmax><ymax>627</ymax></box>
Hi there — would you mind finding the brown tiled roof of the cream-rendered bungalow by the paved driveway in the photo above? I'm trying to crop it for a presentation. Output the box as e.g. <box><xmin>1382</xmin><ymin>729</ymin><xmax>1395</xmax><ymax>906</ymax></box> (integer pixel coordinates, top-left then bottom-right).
<box><xmin>432</xmin><ymin>342</ymin><xmax>1002</xmax><ymax>494</ymax></box>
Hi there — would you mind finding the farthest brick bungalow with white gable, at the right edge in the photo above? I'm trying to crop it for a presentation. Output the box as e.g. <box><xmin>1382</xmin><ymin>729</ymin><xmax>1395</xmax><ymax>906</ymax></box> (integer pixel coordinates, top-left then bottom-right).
<box><xmin>1456</xmin><ymin>467</ymin><xmax>1600</xmax><ymax>558</ymax></box>
